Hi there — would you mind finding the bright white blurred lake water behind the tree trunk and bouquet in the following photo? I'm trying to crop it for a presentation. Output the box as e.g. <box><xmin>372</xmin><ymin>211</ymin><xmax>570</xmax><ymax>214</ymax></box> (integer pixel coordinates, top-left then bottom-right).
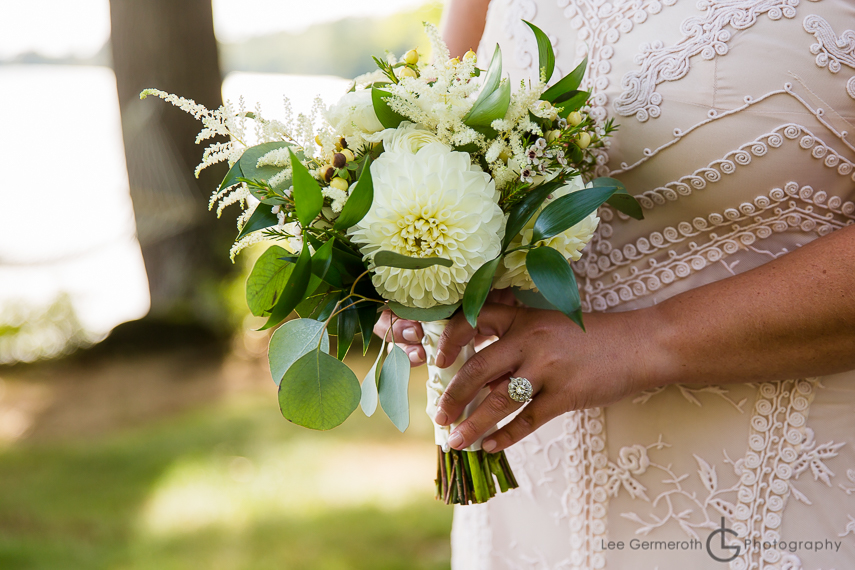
<box><xmin>0</xmin><ymin>65</ymin><xmax>348</xmax><ymax>340</ymax></box>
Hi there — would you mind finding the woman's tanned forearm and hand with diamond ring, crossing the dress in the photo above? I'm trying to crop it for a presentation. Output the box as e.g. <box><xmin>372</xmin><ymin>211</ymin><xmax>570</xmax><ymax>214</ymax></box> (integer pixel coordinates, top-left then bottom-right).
<box><xmin>437</xmin><ymin>222</ymin><xmax>855</xmax><ymax>451</ymax></box>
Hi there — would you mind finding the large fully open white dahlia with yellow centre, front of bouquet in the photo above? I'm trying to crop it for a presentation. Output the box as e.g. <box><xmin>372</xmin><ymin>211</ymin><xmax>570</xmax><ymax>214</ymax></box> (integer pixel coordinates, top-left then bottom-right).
<box><xmin>352</xmin><ymin>143</ymin><xmax>504</xmax><ymax>308</ymax></box>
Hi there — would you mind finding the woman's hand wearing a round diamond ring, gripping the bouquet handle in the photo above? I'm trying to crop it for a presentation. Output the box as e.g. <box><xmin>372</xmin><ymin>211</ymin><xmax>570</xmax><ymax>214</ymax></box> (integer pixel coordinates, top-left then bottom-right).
<box><xmin>436</xmin><ymin>304</ymin><xmax>655</xmax><ymax>452</ymax></box>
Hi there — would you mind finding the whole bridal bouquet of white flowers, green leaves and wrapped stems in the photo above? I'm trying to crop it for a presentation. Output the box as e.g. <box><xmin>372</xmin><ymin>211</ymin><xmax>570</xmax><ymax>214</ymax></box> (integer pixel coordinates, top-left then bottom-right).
<box><xmin>141</xmin><ymin>24</ymin><xmax>641</xmax><ymax>504</ymax></box>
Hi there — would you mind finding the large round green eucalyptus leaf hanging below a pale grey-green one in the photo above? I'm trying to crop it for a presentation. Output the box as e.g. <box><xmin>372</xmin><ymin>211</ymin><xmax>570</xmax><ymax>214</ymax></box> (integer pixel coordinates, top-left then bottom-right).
<box><xmin>279</xmin><ymin>349</ymin><xmax>362</xmax><ymax>430</ymax></box>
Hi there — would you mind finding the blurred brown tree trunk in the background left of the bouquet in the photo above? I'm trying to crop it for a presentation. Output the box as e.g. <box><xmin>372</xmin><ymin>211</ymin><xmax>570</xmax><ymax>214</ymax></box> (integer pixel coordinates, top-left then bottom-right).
<box><xmin>110</xmin><ymin>0</ymin><xmax>236</xmax><ymax>338</ymax></box>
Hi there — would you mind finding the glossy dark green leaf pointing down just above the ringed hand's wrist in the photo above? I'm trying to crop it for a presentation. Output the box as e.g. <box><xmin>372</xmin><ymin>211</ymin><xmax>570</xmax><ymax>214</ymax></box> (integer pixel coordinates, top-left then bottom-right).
<box><xmin>525</xmin><ymin>246</ymin><xmax>585</xmax><ymax>330</ymax></box>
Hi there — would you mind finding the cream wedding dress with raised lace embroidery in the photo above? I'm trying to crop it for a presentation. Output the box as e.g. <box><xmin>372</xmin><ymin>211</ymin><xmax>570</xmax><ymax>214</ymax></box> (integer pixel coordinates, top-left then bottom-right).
<box><xmin>452</xmin><ymin>0</ymin><xmax>855</xmax><ymax>570</ymax></box>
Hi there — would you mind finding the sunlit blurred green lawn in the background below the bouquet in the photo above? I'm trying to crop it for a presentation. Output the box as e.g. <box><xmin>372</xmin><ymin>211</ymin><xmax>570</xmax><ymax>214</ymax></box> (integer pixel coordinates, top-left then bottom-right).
<box><xmin>0</xmin><ymin>388</ymin><xmax>451</xmax><ymax>570</ymax></box>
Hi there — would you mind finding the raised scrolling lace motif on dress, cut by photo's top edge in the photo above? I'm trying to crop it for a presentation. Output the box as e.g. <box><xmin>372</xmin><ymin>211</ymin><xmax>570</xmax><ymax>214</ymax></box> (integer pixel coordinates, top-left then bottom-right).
<box><xmin>614</xmin><ymin>0</ymin><xmax>818</xmax><ymax>122</ymax></box>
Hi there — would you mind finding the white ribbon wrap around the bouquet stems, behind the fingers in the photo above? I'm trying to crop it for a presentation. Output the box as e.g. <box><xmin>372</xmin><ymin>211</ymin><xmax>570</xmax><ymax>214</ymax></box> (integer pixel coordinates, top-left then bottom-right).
<box><xmin>422</xmin><ymin>320</ymin><xmax>496</xmax><ymax>451</ymax></box>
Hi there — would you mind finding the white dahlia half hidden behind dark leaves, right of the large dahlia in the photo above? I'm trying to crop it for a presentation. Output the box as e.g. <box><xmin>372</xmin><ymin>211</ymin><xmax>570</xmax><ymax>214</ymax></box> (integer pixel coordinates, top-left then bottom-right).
<box><xmin>493</xmin><ymin>177</ymin><xmax>600</xmax><ymax>289</ymax></box>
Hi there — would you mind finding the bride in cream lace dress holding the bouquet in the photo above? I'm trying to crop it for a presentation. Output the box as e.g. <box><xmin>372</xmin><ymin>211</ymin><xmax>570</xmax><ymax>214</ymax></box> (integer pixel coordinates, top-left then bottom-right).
<box><xmin>378</xmin><ymin>0</ymin><xmax>855</xmax><ymax>570</ymax></box>
